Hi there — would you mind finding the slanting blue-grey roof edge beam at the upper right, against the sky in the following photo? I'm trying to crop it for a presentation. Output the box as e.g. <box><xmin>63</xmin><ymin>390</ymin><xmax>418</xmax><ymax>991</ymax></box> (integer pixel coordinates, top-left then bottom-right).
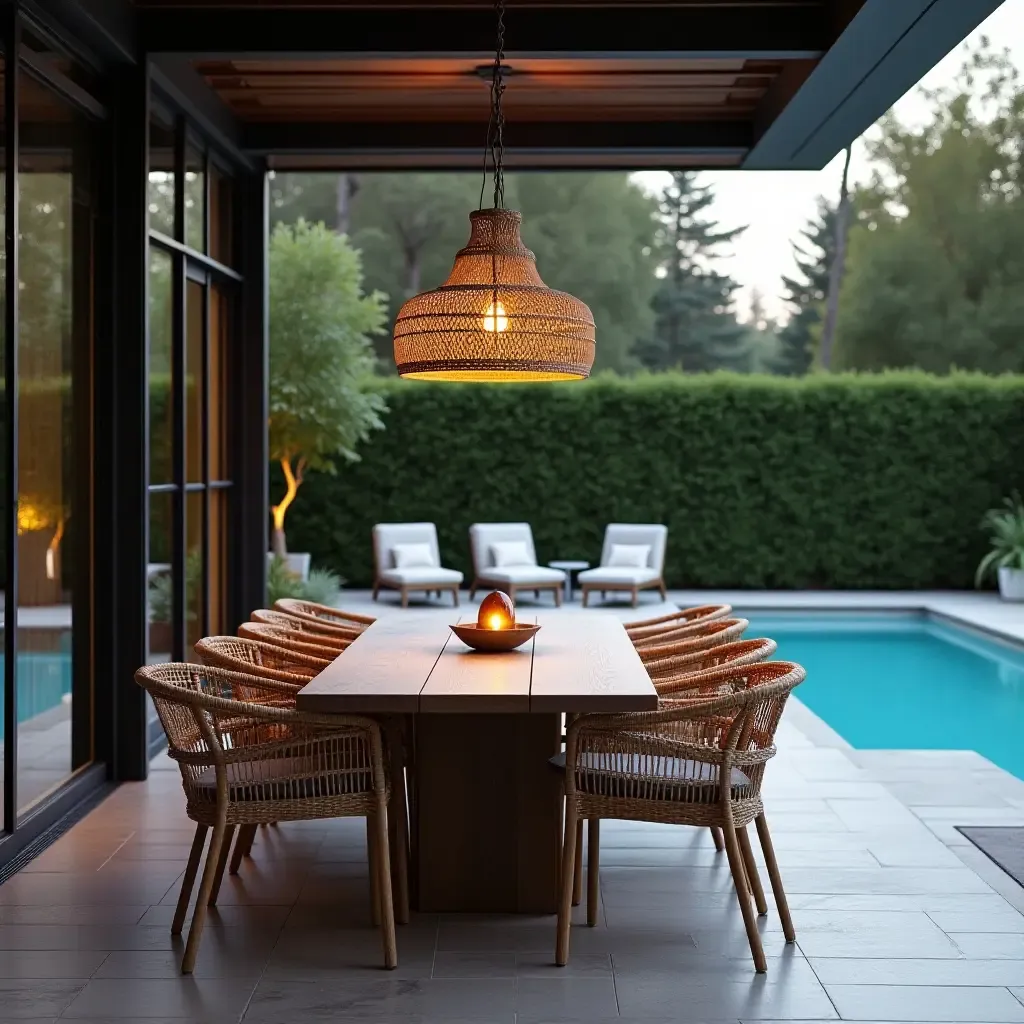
<box><xmin>743</xmin><ymin>0</ymin><xmax>1001</xmax><ymax>170</ymax></box>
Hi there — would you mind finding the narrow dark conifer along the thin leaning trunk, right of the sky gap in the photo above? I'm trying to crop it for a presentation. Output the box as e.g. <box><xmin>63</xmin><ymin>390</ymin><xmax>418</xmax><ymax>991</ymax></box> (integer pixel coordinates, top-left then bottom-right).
<box><xmin>775</xmin><ymin>196</ymin><xmax>837</xmax><ymax>377</ymax></box>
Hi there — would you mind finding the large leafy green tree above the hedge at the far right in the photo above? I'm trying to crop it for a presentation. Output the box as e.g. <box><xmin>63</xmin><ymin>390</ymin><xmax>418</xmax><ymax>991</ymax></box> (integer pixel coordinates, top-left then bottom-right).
<box><xmin>836</xmin><ymin>45</ymin><xmax>1024</xmax><ymax>373</ymax></box>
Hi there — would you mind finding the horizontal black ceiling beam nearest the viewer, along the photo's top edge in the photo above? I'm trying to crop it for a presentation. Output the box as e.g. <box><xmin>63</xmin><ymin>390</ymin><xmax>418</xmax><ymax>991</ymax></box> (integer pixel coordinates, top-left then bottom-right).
<box><xmin>139</xmin><ymin>3</ymin><xmax>831</xmax><ymax>59</ymax></box>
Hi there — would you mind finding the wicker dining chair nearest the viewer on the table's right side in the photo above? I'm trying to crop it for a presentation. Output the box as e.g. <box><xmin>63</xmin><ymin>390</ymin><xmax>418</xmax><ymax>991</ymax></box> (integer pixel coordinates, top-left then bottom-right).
<box><xmin>552</xmin><ymin>662</ymin><xmax>805</xmax><ymax>973</ymax></box>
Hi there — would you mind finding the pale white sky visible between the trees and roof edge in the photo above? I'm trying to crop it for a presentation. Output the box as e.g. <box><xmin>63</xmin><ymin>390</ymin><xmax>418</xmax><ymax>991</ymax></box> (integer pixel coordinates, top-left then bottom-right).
<box><xmin>638</xmin><ymin>0</ymin><xmax>1024</xmax><ymax>316</ymax></box>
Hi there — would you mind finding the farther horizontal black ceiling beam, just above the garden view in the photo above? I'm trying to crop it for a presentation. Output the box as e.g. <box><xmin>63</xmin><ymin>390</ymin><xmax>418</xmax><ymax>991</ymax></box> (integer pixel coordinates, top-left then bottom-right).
<box><xmin>243</xmin><ymin>121</ymin><xmax>751</xmax><ymax>169</ymax></box>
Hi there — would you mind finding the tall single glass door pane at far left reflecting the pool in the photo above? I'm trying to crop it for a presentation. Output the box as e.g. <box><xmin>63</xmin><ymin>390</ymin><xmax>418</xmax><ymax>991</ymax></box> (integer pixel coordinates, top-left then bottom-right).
<box><xmin>6</xmin><ymin>59</ymin><xmax>93</xmax><ymax>817</ymax></box>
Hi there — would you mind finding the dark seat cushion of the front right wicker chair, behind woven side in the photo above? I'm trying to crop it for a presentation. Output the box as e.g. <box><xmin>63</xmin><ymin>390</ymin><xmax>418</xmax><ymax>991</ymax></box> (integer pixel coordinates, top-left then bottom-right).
<box><xmin>548</xmin><ymin>751</ymin><xmax>751</xmax><ymax>804</ymax></box>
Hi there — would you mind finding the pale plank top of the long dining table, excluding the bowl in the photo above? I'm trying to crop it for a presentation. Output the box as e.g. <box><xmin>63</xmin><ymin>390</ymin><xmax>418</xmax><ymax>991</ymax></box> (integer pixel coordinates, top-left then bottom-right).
<box><xmin>297</xmin><ymin>611</ymin><xmax>657</xmax><ymax>714</ymax></box>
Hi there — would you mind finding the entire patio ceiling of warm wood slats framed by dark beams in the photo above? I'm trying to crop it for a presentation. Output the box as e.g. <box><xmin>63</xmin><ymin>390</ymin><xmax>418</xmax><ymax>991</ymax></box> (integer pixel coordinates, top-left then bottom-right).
<box><xmin>137</xmin><ymin>0</ymin><xmax>999</xmax><ymax>169</ymax></box>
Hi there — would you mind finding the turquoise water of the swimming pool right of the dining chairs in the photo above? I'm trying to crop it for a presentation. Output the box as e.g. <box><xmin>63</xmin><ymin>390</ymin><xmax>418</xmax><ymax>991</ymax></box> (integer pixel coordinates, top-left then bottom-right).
<box><xmin>745</xmin><ymin>612</ymin><xmax>1024</xmax><ymax>778</ymax></box>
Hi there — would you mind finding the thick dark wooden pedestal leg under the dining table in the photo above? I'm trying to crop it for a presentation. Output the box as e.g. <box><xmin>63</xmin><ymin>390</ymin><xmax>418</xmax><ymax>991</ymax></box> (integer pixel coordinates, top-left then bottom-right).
<box><xmin>414</xmin><ymin>714</ymin><xmax>562</xmax><ymax>913</ymax></box>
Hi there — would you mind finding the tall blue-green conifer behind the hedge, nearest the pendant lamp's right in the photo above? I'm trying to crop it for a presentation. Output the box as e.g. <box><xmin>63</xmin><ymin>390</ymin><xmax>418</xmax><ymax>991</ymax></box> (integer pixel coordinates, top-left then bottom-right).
<box><xmin>636</xmin><ymin>171</ymin><xmax>750</xmax><ymax>373</ymax></box>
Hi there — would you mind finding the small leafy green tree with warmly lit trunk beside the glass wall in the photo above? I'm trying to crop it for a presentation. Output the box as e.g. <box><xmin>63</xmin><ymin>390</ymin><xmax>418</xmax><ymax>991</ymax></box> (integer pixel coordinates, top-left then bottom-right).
<box><xmin>269</xmin><ymin>220</ymin><xmax>387</xmax><ymax>556</ymax></box>
